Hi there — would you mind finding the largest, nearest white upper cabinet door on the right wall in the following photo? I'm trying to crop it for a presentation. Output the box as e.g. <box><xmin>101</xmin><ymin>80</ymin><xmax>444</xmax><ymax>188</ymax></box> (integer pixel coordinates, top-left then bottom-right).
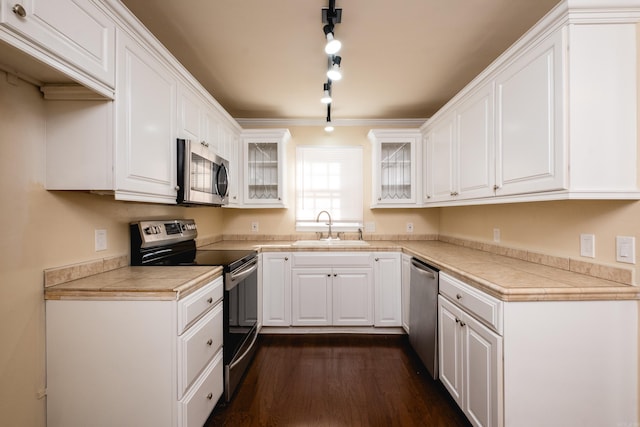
<box><xmin>496</xmin><ymin>26</ymin><xmax>567</xmax><ymax>195</ymax></box>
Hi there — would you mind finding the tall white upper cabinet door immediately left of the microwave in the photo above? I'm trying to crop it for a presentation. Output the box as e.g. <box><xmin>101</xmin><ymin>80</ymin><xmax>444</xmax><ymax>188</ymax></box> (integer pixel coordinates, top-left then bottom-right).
<box><xmin>115</xmin><ymin>31</ymin><xmax>177</xmax><ymax>203</ymax></box>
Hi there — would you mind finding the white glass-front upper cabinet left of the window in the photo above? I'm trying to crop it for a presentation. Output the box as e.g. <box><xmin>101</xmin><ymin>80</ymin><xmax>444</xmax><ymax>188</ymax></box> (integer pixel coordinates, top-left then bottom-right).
<box><xmin>241</xmin><ymin>129</ymin><xmax>291</xmax><ymax>208</ymax></box>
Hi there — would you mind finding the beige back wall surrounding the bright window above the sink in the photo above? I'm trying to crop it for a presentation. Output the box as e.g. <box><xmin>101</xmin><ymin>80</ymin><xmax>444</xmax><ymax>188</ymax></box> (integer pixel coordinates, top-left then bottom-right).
<box><xmin>225</xmin><ymin>126</ymin><xmax>439</xmax><ymax>234</ymax></box>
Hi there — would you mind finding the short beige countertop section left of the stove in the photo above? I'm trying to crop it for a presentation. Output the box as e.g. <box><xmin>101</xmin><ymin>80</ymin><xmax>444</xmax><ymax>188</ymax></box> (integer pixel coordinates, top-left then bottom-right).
<box><xmin>44</xmin><ymin>266</ymin><xmax>222</xmax><ymax>300</ymax></box>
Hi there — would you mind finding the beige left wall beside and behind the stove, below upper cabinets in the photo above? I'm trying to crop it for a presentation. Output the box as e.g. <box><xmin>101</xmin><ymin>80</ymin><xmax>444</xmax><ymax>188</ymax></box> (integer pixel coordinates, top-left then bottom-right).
<box><xmin>0</xmin><ymin>72</ymin><xmax>223</xmax><ymax>427</ymax></box>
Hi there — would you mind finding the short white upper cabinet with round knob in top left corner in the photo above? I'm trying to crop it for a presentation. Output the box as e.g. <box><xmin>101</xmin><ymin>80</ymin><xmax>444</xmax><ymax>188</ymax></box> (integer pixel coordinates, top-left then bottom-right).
<box><xmin>0</xmin><ymin>0</ymin><xmax>115</xmax><ymax>98</ymax></box>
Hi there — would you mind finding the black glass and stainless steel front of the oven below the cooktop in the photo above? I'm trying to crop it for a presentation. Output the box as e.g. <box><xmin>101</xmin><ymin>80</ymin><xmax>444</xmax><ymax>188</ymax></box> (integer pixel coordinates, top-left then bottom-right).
<box><xmin>223</xmin><ymin>257</ymin><xmax>258</xmax><ymax>401</ymax></box>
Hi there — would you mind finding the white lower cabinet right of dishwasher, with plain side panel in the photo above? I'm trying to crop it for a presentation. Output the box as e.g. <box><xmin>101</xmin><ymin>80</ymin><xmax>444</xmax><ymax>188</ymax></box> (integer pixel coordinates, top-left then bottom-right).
<box><xmin>438</xmin><ymin>271</ymin><xmax>640</xmax><ymax>427</ymax></box>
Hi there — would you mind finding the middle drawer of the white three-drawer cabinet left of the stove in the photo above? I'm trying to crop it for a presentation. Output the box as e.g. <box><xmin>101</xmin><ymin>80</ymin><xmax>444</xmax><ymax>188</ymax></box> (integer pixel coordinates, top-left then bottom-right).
<box><xmin>178</xmin><ymin>302</ymin><xmax>223</xmax><ymax>398</ymax></box>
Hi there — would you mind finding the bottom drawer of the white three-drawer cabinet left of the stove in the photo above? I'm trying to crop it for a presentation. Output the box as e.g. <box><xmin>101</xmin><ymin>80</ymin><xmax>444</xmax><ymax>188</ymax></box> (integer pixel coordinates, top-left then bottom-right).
<box><xmin>178</xmin><ymin>349</ymin><xmax>224</xmax><ymax>427</ymax></box>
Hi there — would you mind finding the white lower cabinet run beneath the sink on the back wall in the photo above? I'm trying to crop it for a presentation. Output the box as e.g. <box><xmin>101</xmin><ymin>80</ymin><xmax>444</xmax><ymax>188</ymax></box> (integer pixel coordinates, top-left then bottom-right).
<box><xmin>261</xmin><ymin>251</ymin><xmax>402</xmax><ymax>327</ymax></box>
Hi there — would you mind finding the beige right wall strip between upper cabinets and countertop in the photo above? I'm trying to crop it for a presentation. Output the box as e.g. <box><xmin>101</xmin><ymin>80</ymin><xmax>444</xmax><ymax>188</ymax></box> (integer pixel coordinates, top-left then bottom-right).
<box><xmin>440</xmin><ymin>200</ymin><xmax>640</xmax><ymax>282</ymax></box>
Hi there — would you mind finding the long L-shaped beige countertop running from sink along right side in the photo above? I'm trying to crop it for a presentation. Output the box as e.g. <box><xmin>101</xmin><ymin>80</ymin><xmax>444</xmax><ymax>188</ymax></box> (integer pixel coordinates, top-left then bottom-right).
<box><xmin>199</xmin><ymin>240</ymin><xmax>640</xmax><ymax>301</ymax></box>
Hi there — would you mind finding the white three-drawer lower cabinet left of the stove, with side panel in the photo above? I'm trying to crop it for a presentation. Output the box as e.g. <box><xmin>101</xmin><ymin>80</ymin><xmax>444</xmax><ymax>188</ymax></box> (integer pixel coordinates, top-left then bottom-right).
<box><xmin>46</xmin><ymin>277</ymin><xmax>224</xmax><ymax>427</ymax></box>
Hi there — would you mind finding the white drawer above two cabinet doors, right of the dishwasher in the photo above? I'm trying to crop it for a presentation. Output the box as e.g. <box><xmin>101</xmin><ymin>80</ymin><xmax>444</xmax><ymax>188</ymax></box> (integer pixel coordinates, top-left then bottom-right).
<box><xmin>440</xmin><ymin>272</ymin><xmax>502</xmax><ymax>335</ymax></box>
